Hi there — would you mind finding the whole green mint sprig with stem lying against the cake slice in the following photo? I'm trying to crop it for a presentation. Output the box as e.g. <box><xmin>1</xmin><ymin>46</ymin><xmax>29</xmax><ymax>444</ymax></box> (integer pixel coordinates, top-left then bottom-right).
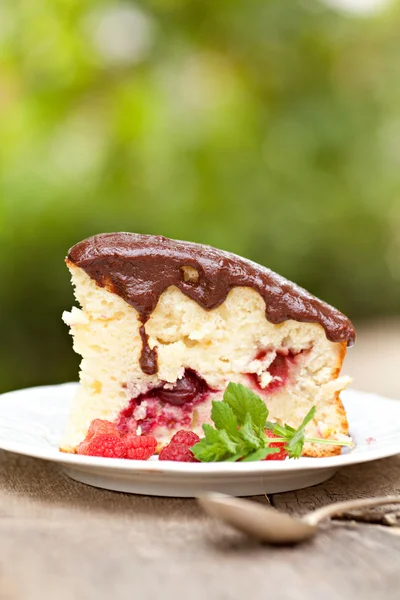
<box><xmin>192</xmin><ymin>383</ymin><xmax>351</xmax><ymax>462</ymax></box>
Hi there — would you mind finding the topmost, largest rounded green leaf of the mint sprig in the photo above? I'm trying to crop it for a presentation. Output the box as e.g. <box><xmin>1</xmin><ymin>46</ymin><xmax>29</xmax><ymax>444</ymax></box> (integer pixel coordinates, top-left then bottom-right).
<box><xmin>224</xmin><ymin>382</ymin><xmax>268</xmax><ymax>433</ymax></box>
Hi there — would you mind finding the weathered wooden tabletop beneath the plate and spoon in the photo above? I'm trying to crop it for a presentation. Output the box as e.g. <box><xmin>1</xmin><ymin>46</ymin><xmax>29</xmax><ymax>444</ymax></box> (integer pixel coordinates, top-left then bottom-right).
<box><xmin>0</xmin><ymin>451</ymin><xmax>400</xmax><ymax>600</ymax></box>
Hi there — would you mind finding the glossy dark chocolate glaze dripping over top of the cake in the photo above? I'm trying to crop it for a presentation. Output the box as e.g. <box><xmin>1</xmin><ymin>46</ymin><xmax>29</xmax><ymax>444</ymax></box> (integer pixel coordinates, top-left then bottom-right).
<box><xmin>67</xmin><ymin>233</ymin><xmax>355</xmax><ymax>375</ymax></box>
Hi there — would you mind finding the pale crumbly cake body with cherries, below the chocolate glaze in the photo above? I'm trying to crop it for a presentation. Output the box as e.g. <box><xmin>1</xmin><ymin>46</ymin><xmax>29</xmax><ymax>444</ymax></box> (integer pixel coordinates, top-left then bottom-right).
<box><xmin>61</xmin><ymin>236</ymin><xmax>349</xmax><ymax>456</ymax></box>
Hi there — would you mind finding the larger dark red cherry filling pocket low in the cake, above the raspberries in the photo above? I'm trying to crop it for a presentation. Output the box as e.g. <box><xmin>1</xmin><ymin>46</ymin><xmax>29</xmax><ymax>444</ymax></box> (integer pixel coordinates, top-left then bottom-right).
<box><xmin>116</xmin><ymin>369</ymin><xmax>212</xmax><ymax>434</ymax></box>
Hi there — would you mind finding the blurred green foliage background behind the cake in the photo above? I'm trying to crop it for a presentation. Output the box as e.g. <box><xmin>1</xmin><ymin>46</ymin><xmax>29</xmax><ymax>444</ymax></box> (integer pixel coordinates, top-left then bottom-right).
<box><xmin>0</xmin><ymin>0</ymin><xmax>400</xmax><ymax>391</ymax></box>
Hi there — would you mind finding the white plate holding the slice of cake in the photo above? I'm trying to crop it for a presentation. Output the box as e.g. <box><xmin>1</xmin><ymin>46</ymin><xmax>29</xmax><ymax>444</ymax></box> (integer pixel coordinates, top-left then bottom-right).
<box><xmin>0</xmin><ymin>383</ymin><xmax>400</xmax><ymax>497</ymax></box>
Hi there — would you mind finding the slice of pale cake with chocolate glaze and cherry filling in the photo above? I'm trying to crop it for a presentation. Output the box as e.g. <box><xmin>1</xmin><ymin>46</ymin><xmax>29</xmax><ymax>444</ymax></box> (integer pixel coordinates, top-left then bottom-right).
<box><xmin>61</xmin><ymin>233</ymin><xmax>355</xmax><ymax>456</ymax></box>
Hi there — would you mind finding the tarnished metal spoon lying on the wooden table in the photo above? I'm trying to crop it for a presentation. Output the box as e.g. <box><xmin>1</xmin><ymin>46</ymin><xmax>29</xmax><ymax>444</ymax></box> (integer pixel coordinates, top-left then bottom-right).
<box><xmin>198</xmin><ymin>493</ymin><xmax>400</xmax><ymax>544</ymax></box>
